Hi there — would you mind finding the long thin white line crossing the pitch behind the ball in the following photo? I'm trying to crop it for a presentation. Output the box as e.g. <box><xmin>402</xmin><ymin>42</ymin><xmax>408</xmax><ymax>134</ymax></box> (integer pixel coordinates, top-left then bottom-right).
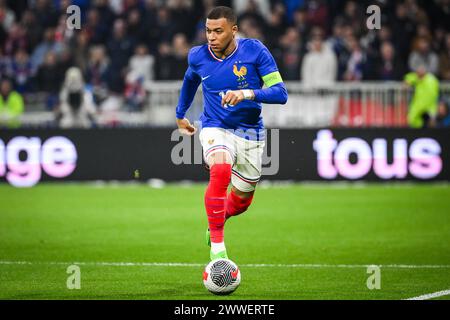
<box><xmin>0</xmin><ymin>260</ymin><xmax>450</xmax><ymax>269</ymax></box>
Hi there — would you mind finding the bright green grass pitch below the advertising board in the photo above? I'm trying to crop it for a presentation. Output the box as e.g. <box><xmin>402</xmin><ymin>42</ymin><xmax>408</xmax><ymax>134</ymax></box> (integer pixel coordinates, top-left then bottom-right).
<box><xmin>0</xmin><ymin>183</ymin><xmax>450</xmax><ymax>299</ymax></box>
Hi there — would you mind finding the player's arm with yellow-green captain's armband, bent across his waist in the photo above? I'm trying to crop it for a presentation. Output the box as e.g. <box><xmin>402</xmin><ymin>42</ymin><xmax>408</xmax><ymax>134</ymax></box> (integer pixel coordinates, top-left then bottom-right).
<box><xmin>222</xmin><ymin>44</ymin><xmax>288</xmax><ymax>105</ymax></box>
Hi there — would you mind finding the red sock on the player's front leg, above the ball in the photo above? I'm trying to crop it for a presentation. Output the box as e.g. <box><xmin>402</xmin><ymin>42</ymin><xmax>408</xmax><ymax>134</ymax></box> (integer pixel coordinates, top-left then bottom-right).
<box><xmin>205</xmin><ymin>163</ymin><xmax>231</xmax><ymax>243</ymax></box>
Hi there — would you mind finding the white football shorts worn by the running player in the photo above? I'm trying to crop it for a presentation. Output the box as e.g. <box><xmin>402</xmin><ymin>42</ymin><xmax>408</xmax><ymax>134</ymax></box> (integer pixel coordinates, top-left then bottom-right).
<box><xmin>199</xmin><ymin>128</ymin><xmax>265</xmax><ymax>192</ymax></box>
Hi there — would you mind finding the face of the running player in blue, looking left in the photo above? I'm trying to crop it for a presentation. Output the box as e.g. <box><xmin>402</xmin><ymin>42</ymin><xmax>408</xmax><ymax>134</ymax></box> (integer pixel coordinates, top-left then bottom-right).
<box><xmin>206</xmin><ymin>18</ymin><xmax>237</xmax><ymax>52</ymax></box>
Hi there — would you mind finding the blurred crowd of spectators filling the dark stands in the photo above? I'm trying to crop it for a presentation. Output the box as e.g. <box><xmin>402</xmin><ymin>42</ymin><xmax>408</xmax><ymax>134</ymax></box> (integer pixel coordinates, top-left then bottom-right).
<box><xmin>0</xmin><ymin>0</ymin><xmax>450</xmax><ymax>127</ymax></box>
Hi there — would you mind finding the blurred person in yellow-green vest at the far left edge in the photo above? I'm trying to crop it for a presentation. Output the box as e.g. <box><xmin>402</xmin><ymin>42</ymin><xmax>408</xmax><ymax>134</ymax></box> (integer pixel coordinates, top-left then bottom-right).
<box><xmin>0</xmin><ymin>78</ymin><xmax>24</xmax><ymax>128</ymax></box>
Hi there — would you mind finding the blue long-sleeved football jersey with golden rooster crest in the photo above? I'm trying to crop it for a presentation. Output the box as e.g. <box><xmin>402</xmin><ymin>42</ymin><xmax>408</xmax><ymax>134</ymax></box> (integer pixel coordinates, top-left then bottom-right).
<box><xmin>177</xmin><ymin>39</ymin><xmax>282</xmax><ymax>140</ymax></box>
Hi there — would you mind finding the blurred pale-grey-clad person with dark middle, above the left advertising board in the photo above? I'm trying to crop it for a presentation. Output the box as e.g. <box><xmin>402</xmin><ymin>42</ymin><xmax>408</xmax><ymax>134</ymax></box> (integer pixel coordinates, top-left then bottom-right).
<box><xmin>59</xmin><ymin>67</ymin><xmax>96</xmax><ymax>128</ymax></box>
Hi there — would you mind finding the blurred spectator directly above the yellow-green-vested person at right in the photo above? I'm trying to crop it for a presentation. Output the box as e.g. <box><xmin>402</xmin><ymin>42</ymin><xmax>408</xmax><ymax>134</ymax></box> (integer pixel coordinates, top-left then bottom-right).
<box><xmin>408</xmin><ymin>37</ymin><xmax>439</xmax><ymax>75</ymax></box>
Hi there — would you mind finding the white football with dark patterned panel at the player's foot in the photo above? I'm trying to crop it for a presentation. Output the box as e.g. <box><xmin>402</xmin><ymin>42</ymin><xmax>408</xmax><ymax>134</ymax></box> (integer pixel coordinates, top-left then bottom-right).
<box><xmin>203</xmin><ymin>259</ymin><xmax>241</xmax><ymax>295</ymax></box>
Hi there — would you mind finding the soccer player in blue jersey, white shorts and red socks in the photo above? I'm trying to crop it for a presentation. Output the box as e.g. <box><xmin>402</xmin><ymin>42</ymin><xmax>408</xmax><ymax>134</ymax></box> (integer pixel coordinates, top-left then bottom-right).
<box><xmin>176</xmin><ymin>6</ymin><xmax>287</xmax><ymax>260</ymax></box>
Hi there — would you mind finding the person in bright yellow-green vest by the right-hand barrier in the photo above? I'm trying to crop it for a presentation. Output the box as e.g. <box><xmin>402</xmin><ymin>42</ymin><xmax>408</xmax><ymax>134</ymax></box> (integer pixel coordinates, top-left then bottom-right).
<box><xmin>404</xmin><ymin>65</ymin><xmax>439</xmax><ymax>128</ymax></box>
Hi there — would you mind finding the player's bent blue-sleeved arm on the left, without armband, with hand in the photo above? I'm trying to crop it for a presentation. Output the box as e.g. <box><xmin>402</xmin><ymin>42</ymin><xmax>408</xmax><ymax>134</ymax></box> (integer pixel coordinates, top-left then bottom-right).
<box><xmin>176</xmin><ymin>50</ymin><xmax>202</xmax><ymax>135</ymax></box>
